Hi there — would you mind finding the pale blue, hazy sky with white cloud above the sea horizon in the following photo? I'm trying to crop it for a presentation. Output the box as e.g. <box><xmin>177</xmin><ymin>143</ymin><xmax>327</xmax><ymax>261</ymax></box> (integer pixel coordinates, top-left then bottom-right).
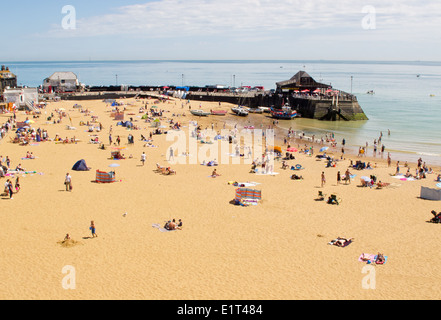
<box><xmin>0</xmin><ymin>0</ymin><xmax>441</xmax><ymax>62</ymax></box>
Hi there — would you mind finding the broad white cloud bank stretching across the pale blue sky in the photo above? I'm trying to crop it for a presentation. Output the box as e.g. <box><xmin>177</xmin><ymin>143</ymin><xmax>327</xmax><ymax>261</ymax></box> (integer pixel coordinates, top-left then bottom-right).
<box><xmin>46</xmin><ymin>0</ymin><xmax>441</xmax><ymax>38</ymax></box>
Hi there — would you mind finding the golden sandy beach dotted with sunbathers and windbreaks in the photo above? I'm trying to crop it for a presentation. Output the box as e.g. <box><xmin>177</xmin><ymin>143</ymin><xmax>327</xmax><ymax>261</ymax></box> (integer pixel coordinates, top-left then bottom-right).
<box><xmin>0</xmin><ymin>99</ymin><xmax>441</xmax><ymax>300</ymax></box>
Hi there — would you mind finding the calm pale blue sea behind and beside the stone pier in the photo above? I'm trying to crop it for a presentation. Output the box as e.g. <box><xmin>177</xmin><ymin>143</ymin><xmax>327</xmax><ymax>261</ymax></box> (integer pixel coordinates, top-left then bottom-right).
<box><xmin>5</xmin><ymin>60</ymin><xmax>441</xmax><ymax>165</ymax></box>
